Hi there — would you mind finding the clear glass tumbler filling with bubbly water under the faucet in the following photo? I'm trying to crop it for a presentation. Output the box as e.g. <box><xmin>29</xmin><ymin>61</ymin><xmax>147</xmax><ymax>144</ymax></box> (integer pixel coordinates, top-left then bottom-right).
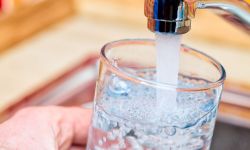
<box><xmin>87</xmin><ymin>39</ymin><xmax>226</xmax><ymax>150</ymax></box>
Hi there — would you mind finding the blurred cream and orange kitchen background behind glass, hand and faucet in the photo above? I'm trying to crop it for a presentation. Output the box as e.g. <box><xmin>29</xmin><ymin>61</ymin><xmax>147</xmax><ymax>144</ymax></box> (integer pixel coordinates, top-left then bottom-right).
<box><xmin>0</xmin><ymin>0</ymin><xmax>250</xmax><ymax>150</ymax></box>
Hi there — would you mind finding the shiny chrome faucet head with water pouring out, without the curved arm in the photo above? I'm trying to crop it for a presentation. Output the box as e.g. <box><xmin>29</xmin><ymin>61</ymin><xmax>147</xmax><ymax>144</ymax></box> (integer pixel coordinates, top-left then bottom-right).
<box><xmin>144</xmin><ymin>0</ymin><xmax>195</xmax><ymax>34</ymax></box>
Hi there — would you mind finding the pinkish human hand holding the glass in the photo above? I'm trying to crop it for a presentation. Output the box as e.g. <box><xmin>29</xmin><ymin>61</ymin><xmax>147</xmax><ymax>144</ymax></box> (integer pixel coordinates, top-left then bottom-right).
<box><xmin>0</xmin><ymin>106</ymin><xmax>91</xmax><ymax>150</ymax></box>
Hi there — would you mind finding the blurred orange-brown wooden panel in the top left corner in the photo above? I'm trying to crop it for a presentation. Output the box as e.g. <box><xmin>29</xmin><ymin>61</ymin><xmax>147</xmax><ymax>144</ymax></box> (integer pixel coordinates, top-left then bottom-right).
<box><xmin>0</xmin><ymin>0</ymin><xmax>74</xmax><ymax>53</ymax></box>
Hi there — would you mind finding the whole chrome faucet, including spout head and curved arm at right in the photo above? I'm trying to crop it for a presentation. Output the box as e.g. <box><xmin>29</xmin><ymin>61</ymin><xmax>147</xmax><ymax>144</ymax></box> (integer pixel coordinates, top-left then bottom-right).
<box><xmin>144</xmin><ymin>0</ymin><xmax>250</xmax><ymax>34</ymax></box>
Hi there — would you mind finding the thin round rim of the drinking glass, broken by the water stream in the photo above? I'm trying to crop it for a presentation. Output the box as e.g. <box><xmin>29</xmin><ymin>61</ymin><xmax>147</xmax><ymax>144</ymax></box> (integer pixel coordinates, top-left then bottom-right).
<box><xmin>100</xmin><ymin>39</ymin><xmax>226</xmax><ymax>92</ymax></box>
